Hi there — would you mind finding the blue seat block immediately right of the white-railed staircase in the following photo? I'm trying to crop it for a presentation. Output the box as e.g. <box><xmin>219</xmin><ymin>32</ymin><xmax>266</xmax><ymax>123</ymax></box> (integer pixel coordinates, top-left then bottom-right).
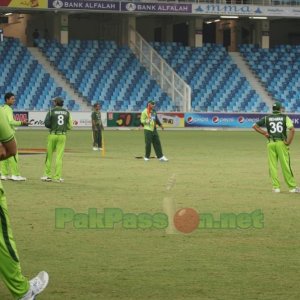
<box><xmin>152</xmin><ymin>42</ymin><xmax>268</xmax><ymax>112</ymax></box>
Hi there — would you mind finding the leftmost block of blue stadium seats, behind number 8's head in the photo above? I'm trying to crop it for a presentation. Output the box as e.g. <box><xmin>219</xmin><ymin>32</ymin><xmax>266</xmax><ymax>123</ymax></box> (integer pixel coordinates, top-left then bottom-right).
<box><xmin>0</xmin><ymin>38</ymin><xmax>80</xmax><ymax>110</ymax></box>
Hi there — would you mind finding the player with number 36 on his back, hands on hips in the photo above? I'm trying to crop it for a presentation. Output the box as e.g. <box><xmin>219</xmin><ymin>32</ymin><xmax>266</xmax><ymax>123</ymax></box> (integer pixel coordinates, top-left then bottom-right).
<box><xmin>253</xmin><ymin>102</ymin><xmax>300</xmax><ymax>193</ymax></box>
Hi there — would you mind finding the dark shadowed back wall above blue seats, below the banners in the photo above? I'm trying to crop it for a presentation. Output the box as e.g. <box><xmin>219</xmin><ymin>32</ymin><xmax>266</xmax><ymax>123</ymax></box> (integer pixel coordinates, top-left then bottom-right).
<box><xmin>0</xmin><ymin>11</ymin><xmax>300</xmax><ymax>51</ymax></box>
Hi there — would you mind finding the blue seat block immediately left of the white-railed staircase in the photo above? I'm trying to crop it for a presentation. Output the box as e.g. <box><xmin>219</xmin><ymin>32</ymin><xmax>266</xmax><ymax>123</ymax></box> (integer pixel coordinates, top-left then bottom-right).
<box><xmin>38</xmin><ymin>39</ymin><xmax>173</xmax><ymax>111</ymax></box>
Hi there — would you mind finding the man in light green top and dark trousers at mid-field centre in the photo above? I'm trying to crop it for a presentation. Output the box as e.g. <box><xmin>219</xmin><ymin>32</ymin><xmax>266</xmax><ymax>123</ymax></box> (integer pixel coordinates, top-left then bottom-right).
<box><xmin>141</xmin><ymin>100</ymin><xmax>168</xmax><ymax>162</ymax></box>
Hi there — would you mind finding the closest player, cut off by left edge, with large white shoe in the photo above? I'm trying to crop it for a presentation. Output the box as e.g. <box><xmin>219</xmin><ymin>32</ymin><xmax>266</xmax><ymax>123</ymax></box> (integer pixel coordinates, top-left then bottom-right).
<box><xmin>0</xmin><ymin>109</ymin><xmax>49</xmax><ymax>300</ymax></box>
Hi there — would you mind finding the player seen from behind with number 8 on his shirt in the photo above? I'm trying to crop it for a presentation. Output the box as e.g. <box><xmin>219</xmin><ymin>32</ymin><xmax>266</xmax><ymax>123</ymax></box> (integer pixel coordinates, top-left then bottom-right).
<box><xmin>41</xmin><ymin>97</ymin><xmax>72</xmax><ymax>182</ymax></box>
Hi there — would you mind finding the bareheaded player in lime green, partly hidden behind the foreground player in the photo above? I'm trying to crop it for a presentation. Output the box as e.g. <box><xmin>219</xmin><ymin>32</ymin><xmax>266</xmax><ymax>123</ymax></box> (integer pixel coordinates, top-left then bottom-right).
<box><xmin>1</xmin><ymin>92</ymin><xmax>28</xmax><ymax>181</ymax></box>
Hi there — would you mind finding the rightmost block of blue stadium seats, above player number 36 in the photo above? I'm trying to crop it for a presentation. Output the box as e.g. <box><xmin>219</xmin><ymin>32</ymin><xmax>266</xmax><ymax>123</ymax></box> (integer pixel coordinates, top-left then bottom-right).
<box><xmin>240</xmin><ymin>45</ymin><xmax>300</xmax><ymax>112</ymax></box>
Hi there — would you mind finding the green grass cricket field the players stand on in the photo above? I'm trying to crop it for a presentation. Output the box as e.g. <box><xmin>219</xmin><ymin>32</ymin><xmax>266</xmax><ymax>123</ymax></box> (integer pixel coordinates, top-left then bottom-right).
<box><xmin>0</xmin><ymin>130</ymin><xmax>300</xmax><ymax>300</ymax></box>
